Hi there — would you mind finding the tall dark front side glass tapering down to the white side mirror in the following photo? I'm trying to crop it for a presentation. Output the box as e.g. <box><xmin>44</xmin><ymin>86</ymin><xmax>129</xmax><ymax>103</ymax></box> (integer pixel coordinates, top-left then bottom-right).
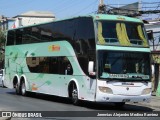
<box><xmin>74</xmin><ymin>17</ymin><xmax>96</xmax><ymax>75</ymax></box>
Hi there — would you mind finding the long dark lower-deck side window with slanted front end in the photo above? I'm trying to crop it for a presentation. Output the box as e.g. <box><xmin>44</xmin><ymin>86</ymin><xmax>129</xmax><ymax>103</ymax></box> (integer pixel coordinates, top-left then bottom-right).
<box><xmin>26</xmin><ymin>57</ymin><xmax>73</xmax><ymax>75</ymax></box>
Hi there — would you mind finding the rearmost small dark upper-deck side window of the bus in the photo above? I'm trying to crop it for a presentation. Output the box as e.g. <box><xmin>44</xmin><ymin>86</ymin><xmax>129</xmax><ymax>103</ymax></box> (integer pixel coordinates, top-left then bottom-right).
<box><xmin>7</xmin><ymin>30</ymin><xmax>15</xmax><ymax>45</ymax></box>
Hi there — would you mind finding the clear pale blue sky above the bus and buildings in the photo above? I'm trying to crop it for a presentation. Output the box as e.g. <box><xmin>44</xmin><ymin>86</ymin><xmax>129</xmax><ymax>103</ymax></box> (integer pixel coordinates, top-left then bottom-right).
<box><xmin>0</xmin><ymin>0</ymin><xmax>160</xmax><ymax>19</ymax></box>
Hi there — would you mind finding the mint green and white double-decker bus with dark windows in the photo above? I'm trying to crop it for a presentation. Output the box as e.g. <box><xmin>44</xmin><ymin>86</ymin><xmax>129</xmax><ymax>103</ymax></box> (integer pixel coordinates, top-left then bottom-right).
<box><xmin>5</xmin><ymin>14</ymin><xmax>151</xmax><ymax>105</ymax></box>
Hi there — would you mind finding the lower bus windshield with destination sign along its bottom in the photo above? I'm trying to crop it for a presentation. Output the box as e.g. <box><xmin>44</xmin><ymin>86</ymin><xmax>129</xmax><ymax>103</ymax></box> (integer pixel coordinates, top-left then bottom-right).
<box><xmin>98</xmin><ymin>51</ymin><xmax>150</xmax><ymax>80</ymax></box>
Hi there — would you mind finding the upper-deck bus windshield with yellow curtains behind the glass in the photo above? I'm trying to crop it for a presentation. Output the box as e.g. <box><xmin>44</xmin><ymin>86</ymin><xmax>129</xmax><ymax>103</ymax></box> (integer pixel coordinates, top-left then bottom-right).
<box><xmin>97</xmin><ymin>21</ymin><xmax>148</xmax><ymax>47</ymax></box>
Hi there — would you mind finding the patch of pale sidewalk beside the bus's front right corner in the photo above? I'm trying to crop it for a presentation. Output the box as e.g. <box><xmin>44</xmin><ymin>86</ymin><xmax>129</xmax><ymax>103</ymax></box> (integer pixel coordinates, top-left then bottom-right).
<box><xmin>133</xmin><ymin>96</ymin><xmax>160</xmax><ymax>109</ymax></box>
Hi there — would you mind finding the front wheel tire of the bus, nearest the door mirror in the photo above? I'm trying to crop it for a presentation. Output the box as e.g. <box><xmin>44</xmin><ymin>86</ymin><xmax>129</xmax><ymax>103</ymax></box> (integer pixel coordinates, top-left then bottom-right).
<box><xmin>71</xmin><ymin>83</ymin><xmax>79</xmax><ymax>105</ymax></box>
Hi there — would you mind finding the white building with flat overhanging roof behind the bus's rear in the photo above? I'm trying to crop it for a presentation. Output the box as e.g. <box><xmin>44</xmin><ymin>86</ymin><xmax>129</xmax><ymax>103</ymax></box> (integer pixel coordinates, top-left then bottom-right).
<box><xmin>12</xmin><ymin>11</ymin><xmax>55</xmax><ymax>28</ymax></box>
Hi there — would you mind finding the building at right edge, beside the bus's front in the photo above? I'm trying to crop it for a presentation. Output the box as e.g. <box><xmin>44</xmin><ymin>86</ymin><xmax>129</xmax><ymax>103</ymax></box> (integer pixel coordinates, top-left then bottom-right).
<box><xmin>145</xmin><ymin>20</ymin><xmax>160</xmax><ymax>96</ymax></box>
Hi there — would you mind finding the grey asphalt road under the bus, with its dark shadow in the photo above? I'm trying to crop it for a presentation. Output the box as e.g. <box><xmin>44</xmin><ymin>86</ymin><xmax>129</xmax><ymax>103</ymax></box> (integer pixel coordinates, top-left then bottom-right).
<box><xmin>0</xmin><ymin>87</ymin><xmax>160</xmax><ymax>120</ymax></box>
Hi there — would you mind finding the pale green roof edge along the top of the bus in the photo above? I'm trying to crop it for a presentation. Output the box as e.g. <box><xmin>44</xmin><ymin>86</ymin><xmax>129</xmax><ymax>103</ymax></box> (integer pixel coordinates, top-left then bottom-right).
<box><xmin>8</xmin><ymin>14</ymin><xmax>143</xmax><ymax>31</ymax></box>
